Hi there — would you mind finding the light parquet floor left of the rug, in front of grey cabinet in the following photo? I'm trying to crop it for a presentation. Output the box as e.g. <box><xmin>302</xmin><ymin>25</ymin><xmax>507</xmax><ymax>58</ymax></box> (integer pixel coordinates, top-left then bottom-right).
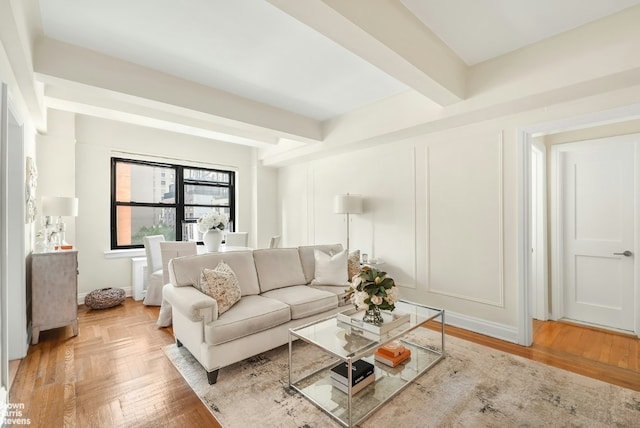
<box><xmin>10</xmin><ymin>299</ymin><xmax>220</xmax><ymax>428</ymax></box>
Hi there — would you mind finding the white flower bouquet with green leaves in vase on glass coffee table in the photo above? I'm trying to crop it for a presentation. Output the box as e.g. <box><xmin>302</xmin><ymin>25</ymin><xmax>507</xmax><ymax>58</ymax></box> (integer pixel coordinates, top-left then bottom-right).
<box><xmin>344</xmin><ymin>266</ymin><xmax>398</xmax><ymax>324</ymax></box>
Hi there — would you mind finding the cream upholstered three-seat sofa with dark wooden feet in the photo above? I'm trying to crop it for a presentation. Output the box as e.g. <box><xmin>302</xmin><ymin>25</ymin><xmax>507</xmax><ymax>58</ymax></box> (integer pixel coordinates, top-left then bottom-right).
<box><xmin>163</xmin><ymin>244</ymin><xmax>348</xmax><ymax>384</ymax></box>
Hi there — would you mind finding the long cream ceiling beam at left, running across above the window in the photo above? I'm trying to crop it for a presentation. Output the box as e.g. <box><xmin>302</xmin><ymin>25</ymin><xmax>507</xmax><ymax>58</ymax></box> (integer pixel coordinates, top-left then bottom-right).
<box><xmin>34</xmin><ymin>37</ymin><xmax>323</xmax><ymax>141</ymax></box>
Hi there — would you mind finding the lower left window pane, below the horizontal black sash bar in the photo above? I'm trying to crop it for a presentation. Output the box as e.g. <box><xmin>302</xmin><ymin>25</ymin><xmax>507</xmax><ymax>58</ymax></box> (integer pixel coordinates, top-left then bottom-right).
<box><xmin>116</xmin><ymin>206</ymin><xmax>176</xmax><ymax>246</ymax></box>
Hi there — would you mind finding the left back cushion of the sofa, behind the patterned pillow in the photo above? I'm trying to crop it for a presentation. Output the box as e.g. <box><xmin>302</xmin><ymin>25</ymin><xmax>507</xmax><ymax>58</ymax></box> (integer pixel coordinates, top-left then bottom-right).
<box><xmin>169</xmin><ymin>251</ymin><xmax>260</xmax><ymax>296</ymax></box>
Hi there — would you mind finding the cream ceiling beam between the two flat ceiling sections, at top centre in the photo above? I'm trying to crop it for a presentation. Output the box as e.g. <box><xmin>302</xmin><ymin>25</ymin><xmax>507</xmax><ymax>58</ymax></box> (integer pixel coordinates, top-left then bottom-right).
<box><xmin>268</xmin><ymin>0</ymin><xmax>467</xmax><ymax>106</ymax></box>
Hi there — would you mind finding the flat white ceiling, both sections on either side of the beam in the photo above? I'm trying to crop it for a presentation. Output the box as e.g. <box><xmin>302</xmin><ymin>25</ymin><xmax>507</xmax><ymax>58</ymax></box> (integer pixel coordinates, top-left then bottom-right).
<box><xmin>39</xmin><ymin>0</ymin><xmax>640</xmax><ymax>126</ymax></box>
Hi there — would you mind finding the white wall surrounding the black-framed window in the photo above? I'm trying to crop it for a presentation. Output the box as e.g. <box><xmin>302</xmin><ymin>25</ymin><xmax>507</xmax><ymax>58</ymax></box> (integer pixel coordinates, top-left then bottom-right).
<box><xmin>49</xmin><ymin>114</ymin><xmax>275</xmax><ymax>298</ymax></box>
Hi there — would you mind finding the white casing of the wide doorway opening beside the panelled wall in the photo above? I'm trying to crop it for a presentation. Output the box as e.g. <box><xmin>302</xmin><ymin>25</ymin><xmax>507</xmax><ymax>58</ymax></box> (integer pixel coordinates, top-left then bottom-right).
<box><xmin>516</xmin><ymin>104</ymin><xmax>640</xmax><ymax>346</ymax></box>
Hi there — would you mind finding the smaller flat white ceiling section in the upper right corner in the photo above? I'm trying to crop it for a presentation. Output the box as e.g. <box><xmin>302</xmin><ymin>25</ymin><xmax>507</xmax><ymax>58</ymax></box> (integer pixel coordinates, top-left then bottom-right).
<box><xmin>401</xmin><ymin>0</ymin><xmax>640</xmax><ymax>65</ymax></box>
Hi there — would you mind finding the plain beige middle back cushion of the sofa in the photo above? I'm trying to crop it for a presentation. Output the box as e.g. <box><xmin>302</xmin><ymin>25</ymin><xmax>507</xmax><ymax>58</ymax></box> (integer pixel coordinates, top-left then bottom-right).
<box><xmin>253</xmin><ymin>248</ymin><xmax>306</xmax><ymax>293</ymax></box>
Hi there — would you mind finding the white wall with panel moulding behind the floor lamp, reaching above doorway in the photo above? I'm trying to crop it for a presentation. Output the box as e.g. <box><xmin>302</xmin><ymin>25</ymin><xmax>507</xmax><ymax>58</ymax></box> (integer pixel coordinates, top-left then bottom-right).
<box><xmin>278</xmin><ymin>87</ymin><xmax>640</xmax><ymax>342</ymax></box>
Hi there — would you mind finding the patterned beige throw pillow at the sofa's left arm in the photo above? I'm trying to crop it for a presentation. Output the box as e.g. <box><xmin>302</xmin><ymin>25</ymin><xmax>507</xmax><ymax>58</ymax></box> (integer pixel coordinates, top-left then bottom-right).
<box><xmin>197</xmin><ymin>262</ymin><xmax>242</xmax><ymax>315</ymax></box>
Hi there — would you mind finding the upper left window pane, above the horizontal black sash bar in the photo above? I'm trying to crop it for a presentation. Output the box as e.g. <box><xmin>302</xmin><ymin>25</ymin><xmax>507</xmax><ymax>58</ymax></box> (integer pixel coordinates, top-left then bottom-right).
<box><xmin>116</xmin><ymin>162</ymin><xmax>176</xmax><ymax>204</ymax></box>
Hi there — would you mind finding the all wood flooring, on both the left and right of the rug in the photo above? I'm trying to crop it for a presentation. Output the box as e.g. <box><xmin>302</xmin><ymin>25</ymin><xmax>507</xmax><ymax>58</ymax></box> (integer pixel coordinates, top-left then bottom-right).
<box><xmin>9</xmin><ymin>299</ymin><xmax>640</xmax><ymax>428</ymax></box>
